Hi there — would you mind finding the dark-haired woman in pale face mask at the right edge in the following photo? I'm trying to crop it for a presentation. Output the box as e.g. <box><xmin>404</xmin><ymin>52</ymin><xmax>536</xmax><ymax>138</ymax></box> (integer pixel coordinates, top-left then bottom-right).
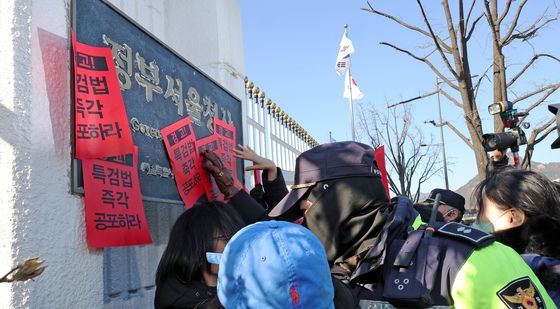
<box><xmin>474</xmin><ymin>169</ymin><xmax>560</xmax><ymax>306</ymax></box>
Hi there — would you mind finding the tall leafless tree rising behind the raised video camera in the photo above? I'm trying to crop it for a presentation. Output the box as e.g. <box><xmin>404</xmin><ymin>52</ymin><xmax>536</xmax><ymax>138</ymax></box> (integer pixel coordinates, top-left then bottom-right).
<box><xmin>363</xmin><ymin>0</ymin><xmax>560</xmax><ymax>178</ymax></box>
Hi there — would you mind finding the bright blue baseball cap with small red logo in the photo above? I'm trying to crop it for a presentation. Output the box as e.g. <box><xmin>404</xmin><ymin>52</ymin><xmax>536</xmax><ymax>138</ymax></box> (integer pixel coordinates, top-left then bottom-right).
<box><xmin>217</xmin><ymin>221</ymin><xmax>334</xmax><ymax>309</ymax></box>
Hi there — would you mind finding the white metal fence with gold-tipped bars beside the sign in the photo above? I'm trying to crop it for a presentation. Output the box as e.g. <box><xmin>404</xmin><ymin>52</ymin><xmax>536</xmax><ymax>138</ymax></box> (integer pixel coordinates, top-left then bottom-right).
<box><xmin>245</xmin><ymin>79</ymin><xmax>318</xmax><ymax>187</ymax></box>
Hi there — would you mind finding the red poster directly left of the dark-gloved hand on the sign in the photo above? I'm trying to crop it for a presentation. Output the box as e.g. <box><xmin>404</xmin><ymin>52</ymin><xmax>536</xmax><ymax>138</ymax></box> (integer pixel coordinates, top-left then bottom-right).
<box><xmin>161</xmin><ymin>116</ymin><xmax>208</xmax><ymax>208</ymax></box>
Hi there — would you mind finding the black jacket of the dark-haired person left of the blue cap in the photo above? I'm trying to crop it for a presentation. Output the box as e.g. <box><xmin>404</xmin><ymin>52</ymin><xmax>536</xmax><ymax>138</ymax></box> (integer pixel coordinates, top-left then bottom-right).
<box><xmin>154</xmin><ymin>278</ymin><xmax>216</xmax><ymax>309</ymax></box>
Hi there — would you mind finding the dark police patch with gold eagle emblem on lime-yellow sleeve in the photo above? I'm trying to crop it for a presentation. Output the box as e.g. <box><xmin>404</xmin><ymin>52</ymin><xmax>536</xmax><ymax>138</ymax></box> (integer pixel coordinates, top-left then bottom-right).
<box><xmin>496</xmin><ymin>277</ymin><xmax>546</xmax><ymax>309</ymax></box>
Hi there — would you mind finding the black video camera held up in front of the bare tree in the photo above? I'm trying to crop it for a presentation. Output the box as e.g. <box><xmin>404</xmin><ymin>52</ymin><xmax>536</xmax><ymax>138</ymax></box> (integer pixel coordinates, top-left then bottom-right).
<box><xmin>482</xmin><ymin>101</ymin><xmax>530</xmax><ymax>152</ymax></box>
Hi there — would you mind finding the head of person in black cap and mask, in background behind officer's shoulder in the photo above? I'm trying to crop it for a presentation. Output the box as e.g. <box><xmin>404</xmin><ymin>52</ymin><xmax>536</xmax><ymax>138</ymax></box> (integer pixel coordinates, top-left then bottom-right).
<box><xmin>415</xmin><ymin>189</ymin><xmax>465</xmax><ymax>222</ymax></box>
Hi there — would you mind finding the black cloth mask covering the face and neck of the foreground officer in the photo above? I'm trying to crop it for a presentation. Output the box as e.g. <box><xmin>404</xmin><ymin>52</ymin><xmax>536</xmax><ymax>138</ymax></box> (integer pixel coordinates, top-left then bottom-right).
<box><xmin>300</xmin><ymin>177</ymin><xmax>388</xmax><ymax>264</ymax></box>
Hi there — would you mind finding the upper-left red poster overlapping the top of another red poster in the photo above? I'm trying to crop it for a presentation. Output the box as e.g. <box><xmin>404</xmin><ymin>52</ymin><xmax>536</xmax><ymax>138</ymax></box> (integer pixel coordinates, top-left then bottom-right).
<box><xmin>72</xmin><ymin>34</ymin><xmax>134</xmax><ymax>159</ymax></box>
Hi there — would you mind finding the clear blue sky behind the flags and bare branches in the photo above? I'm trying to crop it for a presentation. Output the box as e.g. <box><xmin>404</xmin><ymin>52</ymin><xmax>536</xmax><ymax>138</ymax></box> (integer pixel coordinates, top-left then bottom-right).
<box><xmin>239</xmin><ymin>0</ymin><xmax>560</xmax><ymax>191</ymax></box>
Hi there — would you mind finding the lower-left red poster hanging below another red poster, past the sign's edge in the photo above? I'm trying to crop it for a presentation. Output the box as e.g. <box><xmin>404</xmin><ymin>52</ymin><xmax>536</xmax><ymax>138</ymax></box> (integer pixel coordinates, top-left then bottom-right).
<box><xmin>82</xmin><ymin>147</ymin><xmax>152</xmax><ymax>248</ymax></box>
